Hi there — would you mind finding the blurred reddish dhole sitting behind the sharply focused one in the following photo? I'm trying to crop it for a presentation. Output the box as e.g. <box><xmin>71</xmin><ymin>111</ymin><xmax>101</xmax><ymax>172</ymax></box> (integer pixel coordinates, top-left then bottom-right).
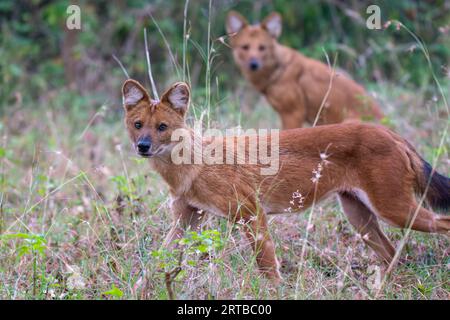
<box><xmin>226</xmin><ymin>11</ymin><xmax>382</xmax><ymax>129</ymax></box>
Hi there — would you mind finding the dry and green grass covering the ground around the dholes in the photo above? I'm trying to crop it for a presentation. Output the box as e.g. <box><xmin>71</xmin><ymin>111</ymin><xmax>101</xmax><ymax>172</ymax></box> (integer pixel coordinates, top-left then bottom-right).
<box><xmin>0</xmin><ymin>7</ymin><xmax>450</xmax><ymax>299</ymax></box>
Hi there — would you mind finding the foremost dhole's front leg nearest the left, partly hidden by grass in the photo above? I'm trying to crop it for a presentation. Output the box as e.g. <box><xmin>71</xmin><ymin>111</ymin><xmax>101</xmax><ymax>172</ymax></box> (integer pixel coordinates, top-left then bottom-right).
<box><xmin>163</xmin><ymin>198</ymin><xmax>204</xmax><ymax>247</ymax></box>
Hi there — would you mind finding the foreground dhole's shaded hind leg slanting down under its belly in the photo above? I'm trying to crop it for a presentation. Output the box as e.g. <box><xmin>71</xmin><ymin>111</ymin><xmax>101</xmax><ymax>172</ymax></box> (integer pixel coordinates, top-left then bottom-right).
<box><xmin>339</xmin><ymin>192</ymin><xmax>395</xmax><ymax>263</ymax></box>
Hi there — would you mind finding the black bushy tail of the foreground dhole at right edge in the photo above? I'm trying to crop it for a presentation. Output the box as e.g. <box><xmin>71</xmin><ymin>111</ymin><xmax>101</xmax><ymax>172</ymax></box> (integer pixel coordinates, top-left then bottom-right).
<box><xmin>423</xmin><ymin>161</ymin><xmax>450</xmax><ymax>213</ymax></box>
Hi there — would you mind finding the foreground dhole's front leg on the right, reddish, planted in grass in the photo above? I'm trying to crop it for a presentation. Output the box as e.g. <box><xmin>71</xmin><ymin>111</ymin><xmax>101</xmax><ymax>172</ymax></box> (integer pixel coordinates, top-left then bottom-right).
<box><xmin>242</xmin><ymin>213</ymin><xmax>282</xmax><ymax>284</ymax></box>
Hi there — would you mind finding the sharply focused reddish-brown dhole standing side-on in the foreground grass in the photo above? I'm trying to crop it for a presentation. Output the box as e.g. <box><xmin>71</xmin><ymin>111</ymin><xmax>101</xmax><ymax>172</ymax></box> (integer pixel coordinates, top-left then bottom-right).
<box><xmin>122</xmin><ymin>80</ymin><xmax>450</xmax><ymax>281</ymax></box>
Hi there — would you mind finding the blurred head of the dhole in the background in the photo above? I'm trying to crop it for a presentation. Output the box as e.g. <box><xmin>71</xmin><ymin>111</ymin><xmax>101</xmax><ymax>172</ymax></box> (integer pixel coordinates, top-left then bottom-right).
<box><xmin>226</xmin><ymin>11</ymin><xmax>281</xmax><ymax>75</ymax></box>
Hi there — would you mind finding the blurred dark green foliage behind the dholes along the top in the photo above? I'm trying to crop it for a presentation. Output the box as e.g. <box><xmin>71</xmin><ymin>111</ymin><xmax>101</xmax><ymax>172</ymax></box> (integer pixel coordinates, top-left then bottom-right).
<box><xmin>0</xmin><ymin>0</ymin><xmax>450</xmax><ymax>113</ymax></box>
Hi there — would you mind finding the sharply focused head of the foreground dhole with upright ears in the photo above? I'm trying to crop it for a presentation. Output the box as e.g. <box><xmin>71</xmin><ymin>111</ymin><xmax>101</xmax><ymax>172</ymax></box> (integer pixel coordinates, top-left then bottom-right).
<box><xmin>122</xmin><ymin>79</ymin><xmax>190</xmax><ymax>158</ymax></box>
